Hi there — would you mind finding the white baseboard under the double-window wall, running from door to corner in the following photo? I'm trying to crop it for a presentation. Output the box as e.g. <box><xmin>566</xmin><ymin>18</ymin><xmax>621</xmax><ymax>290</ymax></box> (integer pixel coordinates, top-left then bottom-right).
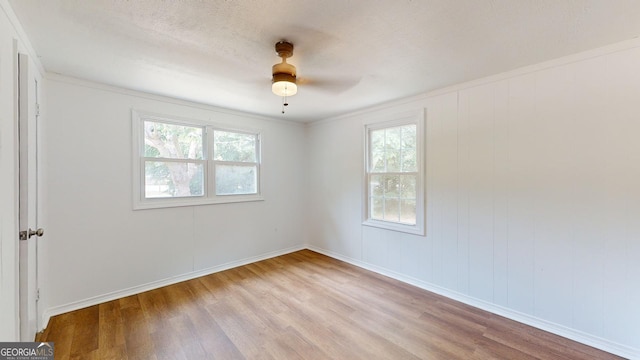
<box><xmin>39</xmin><ymin>245</ymin><xmax>306</xmax><ymax>331</ymax></box>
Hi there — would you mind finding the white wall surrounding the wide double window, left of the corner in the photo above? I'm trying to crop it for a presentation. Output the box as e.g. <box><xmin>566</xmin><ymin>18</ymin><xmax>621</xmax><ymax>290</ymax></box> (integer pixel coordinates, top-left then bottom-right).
<box><xmin>44</xmin><ymin>75</ymin><xmax>306</xmax><ymax>315</ymax></box>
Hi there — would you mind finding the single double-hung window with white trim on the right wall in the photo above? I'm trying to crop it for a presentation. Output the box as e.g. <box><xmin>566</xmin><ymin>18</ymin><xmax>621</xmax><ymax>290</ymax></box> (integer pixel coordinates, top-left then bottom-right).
<box><xmin>364</xmin><ymin>112</ymin><xmax>425</xmax><ymax>235</ymax></box>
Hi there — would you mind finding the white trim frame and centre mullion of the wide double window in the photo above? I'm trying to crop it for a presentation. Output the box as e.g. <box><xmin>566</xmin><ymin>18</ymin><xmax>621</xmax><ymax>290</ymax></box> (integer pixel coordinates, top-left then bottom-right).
<box><xmin>131</xmin><ymin>109</ymin><xmax>264</xmax><ymax>210</ymax></box>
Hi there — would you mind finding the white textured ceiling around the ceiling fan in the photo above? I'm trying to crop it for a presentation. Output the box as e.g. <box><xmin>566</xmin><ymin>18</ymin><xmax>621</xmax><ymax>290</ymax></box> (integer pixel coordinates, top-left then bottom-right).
<box><xmin>10</xmin><ymin>0</ymin><xmax>640</xmax><ymax>122</ymax></box>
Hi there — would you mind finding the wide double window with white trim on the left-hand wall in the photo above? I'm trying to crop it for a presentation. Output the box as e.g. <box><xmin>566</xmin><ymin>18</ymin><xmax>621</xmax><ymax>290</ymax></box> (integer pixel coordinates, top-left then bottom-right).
<box><xmin>132</xmin><ymin>110</ymin><xmax>262</xmax><ymax>209</ymax></box>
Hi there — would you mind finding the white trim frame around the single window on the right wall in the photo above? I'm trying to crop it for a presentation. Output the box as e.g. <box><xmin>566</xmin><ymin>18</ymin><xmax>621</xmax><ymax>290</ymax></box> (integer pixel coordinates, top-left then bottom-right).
<box><xmin>362</xmin><ymin>109</ymin><xmax>426</xmax><ymax>236</ymax></box>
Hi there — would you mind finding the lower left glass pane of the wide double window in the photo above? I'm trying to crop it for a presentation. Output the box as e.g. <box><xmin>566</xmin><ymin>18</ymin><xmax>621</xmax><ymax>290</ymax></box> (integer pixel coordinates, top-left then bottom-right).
<box><xmin>144</xmin><ymin>161</ymin><xmax>204</xmax><ymax>198</ymax></box>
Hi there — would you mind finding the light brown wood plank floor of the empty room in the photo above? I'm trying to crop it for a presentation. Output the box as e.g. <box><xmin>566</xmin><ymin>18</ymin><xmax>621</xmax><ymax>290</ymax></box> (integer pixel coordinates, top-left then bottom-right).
<box><xmin>38</xmin><ymin>250</ymin><xmax>618</xmax><ymax>360</ymax></box>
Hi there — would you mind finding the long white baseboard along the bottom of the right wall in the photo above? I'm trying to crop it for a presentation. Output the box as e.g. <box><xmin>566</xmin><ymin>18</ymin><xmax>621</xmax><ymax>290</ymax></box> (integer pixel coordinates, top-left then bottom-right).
<box><xmin>307</xmin><ymin>245</ymin><xmax>640</xmax><ymax>359</ymax></box>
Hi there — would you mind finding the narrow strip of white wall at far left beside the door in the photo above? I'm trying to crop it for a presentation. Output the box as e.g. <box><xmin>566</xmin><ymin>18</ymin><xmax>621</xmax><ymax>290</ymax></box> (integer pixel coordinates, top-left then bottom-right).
<box><xmin>0</xmin><ymin>0</ymin><xmax>44</xmax><ymax>341</ymax></box>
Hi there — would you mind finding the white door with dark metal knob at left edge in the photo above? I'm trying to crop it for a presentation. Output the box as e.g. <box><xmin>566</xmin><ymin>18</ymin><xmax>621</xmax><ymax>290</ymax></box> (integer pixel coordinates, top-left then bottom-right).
<box><xmin>17</xmin><ymin>54</ymin><xmax>43</xmax><ymax>341</ymax></box>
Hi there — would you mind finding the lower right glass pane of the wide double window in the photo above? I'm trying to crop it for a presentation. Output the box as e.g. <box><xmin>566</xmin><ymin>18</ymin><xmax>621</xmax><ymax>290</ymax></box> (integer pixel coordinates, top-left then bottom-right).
<box><xmin>216</xmin><ymin>165</ymin><xmax>258</xmax><ymax>195</ymax></box>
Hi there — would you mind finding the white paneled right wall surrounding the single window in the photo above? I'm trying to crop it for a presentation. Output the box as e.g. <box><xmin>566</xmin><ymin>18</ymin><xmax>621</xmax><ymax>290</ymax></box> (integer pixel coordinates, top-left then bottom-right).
<box><xmin>308</xmin><ymin>40</ymin><xmax>640</xmax><ymax>358</ymax></box>
